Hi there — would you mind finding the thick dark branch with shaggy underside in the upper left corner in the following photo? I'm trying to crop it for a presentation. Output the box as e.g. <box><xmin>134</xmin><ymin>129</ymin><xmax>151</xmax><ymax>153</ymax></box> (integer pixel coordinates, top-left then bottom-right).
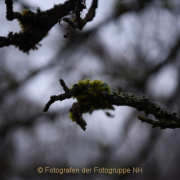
<box><xmin>0</xmin><ymin>0</ymin><xmax>97</xmax><ymax>53</ymax></box>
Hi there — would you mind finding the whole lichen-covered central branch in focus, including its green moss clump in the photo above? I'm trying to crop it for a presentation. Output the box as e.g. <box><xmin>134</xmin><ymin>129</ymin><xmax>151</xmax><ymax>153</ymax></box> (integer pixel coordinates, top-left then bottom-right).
<box><xmin>44</xmin><ymin>79</ymin><xmax>180</xmax><ymax>131</ymax></box>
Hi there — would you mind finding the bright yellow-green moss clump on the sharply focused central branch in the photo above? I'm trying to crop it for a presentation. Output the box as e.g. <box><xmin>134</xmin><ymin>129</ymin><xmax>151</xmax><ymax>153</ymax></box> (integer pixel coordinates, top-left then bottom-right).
<box><xmin>70</xmin><ymin>79</ymin><xmax>112</xmax><ymax>113</ymax></box>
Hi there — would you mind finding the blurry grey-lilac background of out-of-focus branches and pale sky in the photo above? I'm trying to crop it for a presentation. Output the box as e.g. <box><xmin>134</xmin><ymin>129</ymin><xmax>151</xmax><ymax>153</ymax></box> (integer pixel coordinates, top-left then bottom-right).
<box><xmin>0</xmin><ymin>0</ymin><xmax>180</xmax><ymax>180</ymax></box>
